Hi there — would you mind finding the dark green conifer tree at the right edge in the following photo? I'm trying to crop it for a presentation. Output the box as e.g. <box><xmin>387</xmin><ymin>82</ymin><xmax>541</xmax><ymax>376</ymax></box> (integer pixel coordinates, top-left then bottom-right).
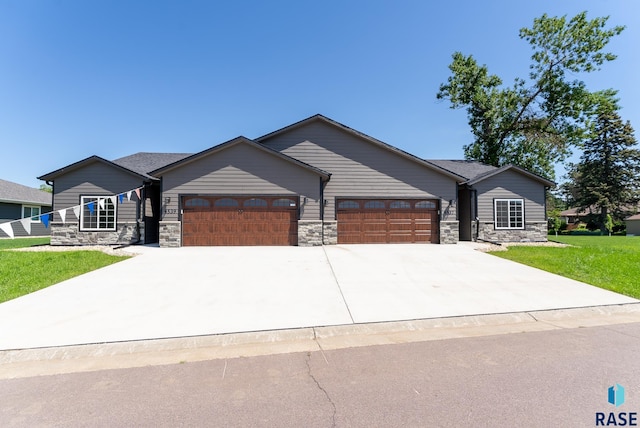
<box><xmin>571</xmin><ymin>109</ymin><xmax>640</xmax><ymax>233</ymax></box>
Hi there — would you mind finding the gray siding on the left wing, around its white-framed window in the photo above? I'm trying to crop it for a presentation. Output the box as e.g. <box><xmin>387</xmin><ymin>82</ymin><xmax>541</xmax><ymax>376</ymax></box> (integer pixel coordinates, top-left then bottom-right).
<box><xmin>53</xmin><ymin>161</ymin><xmax>143</xmax><ymax>222</ymax></box>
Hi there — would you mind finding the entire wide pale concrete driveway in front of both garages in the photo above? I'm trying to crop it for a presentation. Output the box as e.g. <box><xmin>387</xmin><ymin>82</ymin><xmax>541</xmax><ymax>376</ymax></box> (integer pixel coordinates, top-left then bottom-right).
<box><xmin>0</xmin><ymin>244</ymin><xmax>638</xmax><ymax>350</ymax></box>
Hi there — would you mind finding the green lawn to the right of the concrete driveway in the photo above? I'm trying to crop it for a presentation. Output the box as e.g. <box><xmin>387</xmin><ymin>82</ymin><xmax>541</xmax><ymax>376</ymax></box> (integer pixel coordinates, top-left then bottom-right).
<box><xmin>491</xmin><ymin>236</ymin><xmax>640</xmax><ymax>298</ymax></box>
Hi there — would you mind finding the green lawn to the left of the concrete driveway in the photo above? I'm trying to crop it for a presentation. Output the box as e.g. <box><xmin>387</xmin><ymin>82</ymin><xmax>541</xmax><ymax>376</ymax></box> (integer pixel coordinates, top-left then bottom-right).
<box><xmin>0</xmin><ymin>244</ymin><xmax>128</xmax><ymax>303</ymax></box>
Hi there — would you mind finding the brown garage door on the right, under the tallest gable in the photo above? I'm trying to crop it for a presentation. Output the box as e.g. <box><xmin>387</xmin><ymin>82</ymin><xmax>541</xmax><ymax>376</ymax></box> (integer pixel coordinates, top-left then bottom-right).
<box><xmin>336</xmin><ymin>199</ymin><xmax>438</xmax><ymax>244</ymax></box>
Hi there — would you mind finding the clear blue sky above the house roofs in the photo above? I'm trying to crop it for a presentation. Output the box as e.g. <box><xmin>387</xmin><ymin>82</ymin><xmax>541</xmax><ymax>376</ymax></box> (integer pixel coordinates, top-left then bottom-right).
<box><xmin>0</xmin><ymin>0</ymin><xmax>640</xmax><ymax>187</ymax></box>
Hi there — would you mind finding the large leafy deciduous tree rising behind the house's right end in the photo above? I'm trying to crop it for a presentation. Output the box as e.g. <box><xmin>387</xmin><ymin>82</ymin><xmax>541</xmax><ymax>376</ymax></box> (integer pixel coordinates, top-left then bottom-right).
<box><xmin>437</xmin><ymin>12</ymin><xmax>624</xmax><ymax>178</ymax></box>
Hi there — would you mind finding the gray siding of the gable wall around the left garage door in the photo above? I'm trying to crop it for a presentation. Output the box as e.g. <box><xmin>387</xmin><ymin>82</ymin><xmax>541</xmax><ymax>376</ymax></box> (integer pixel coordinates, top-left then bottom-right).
<box><xmin>162</xmin><ymin>143</ymin><xmax>320</xmax><ymax>221</ymax></box>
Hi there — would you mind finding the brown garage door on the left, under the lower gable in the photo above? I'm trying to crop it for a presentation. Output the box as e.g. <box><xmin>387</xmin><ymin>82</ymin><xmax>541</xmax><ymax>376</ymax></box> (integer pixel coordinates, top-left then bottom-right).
<box><xmin>182</xmin><ymin>196</ymin><xmax>298</xmax><ymax>246</ymax></box>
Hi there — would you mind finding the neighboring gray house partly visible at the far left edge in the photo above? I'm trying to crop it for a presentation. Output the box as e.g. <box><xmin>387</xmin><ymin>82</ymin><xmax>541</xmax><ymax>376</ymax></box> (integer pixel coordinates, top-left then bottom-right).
<box><xmin>0</xmin><ymin>180</ymin><xmax>52</xmax><ymax>238</ymax></box>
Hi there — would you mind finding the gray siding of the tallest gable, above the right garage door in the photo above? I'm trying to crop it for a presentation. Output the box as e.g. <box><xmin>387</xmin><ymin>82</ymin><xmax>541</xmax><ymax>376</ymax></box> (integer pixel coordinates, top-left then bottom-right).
<box><xmin>262</xmin><ymin>121</ymin><xmax>456</xmax><ymax>220</ymax></box>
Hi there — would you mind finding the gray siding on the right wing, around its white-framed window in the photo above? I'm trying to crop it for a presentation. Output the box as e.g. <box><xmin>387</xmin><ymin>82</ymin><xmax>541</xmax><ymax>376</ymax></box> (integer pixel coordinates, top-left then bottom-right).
<box><xmin>473</xmin><ymin>171</ymin><xmax>545</xmax><ymax>222</ymax></box>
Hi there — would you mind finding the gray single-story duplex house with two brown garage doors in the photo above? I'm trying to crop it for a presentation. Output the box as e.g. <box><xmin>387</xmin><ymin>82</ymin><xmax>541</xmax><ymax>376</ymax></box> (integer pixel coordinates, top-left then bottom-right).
<box><xmin>39</xmin><ymin>115</ymin><xmax>553</xmax><ymax>247</ymax></box>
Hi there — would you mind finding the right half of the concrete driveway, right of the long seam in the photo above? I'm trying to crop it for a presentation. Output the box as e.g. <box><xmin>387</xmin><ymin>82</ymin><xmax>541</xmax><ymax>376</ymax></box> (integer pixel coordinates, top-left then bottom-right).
<box><xmin>325</xmin><ymin>243</ymin><xmax>637</xmax><ymax>323</ymax></box>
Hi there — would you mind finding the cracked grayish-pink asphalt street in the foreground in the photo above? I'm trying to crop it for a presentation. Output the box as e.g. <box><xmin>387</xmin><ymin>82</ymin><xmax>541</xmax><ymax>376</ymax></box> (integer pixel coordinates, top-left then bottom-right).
<box><xmin>0</xmin><ymin>323</ymin><xmax>640</xmax><ymax>427</ymax></box>
